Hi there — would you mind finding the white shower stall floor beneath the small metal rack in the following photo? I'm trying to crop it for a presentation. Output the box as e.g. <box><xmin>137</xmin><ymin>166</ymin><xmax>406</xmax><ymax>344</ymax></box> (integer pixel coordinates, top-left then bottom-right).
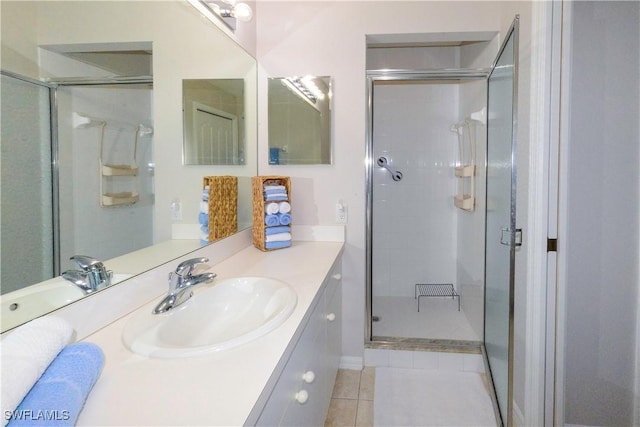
<box><xmin>373</xmin><ymin>297</ymin><xmax>480</xmax><ymax>341</ymax></box>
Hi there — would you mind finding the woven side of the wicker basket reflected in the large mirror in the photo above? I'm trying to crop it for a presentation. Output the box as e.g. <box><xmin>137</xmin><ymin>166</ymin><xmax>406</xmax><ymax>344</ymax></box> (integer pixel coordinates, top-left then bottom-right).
<box><xmin>202</xmin><ymin>176</ymin><xmax>238</xmax><ymax>242</ymax></box>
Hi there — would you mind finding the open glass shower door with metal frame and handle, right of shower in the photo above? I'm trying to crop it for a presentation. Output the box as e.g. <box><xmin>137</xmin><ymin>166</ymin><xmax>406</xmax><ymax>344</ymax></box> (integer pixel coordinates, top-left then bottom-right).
<box><xmin>484</xmin><ymin>17</ymin><xmax>521</xmax><ymax>425</ymax></box>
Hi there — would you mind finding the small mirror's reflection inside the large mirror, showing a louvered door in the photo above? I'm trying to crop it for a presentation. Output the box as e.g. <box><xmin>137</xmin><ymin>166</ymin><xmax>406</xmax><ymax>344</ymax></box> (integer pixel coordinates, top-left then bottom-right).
<box><xmin>182</xmin><ymin>79</ymin><xmax>246</xmax><ymax>165</ymax></box>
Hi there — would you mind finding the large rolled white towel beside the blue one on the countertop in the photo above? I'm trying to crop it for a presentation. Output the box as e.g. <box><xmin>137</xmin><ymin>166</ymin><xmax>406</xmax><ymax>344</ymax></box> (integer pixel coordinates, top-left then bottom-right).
<box><xmin>0</xmin><ymin>317</ymin><xmax>73</xmax><ymax>425</ymax></box>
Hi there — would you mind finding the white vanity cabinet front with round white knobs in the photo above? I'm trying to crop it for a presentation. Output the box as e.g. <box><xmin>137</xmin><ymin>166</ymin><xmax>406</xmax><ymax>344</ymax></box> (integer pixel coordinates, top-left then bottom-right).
<box><xmin>254</xmin><ymin>259</ymin><xmax>342</xmax><ymax>426</ymax></box>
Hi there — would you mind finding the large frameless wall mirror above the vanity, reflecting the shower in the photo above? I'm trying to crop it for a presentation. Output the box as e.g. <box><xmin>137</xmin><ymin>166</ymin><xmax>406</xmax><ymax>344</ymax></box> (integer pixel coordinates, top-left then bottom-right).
<box><xmin>0</xmin><ymin>0</ymin><xmax>257</xmax><ymax>331</ymax></box>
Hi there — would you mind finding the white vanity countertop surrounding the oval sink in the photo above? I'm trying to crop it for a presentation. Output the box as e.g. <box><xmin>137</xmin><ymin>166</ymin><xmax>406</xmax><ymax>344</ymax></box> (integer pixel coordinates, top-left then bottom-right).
<box><xmin>77</xmin><ymin>242</ymin><xmax>343</xmax><ymax>426</ymax></box>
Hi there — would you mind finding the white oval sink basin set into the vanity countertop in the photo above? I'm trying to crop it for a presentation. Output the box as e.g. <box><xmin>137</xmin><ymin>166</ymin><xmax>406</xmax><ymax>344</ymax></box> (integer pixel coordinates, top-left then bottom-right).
<box><xmin>122</xmin><ymin>277</ymin><xmax>298</xmax><ymax>358</ymax></box>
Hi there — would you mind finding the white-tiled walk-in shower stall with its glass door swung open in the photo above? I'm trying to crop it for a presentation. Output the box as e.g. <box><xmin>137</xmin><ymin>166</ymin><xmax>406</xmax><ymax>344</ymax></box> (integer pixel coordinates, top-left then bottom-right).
<box><xmin>366</xmin><ymin>17</ymin><xmax>521</xmax><ymax>425</ymax></box>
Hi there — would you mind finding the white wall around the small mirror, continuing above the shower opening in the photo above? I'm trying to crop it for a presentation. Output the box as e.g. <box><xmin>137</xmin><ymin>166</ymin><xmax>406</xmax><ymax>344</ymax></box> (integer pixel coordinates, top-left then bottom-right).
<box><xmin>257</xmin><ymin>1</ymin><xmax>530</xmax><ymax>378</ymax></box>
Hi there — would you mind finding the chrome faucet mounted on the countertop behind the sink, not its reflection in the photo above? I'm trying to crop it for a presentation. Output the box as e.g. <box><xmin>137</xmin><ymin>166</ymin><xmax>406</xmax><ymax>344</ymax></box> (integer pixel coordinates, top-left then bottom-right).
<box><xmin>153</xmin><ymin>258</ymin><xmax>216</xmax><ymax>314</ymax></box>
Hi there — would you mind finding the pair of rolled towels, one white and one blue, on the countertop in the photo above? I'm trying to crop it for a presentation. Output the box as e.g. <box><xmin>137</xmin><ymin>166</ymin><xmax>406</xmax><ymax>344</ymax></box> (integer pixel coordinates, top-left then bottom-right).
<box><xmin>0</xmin><ymin>317</ymin><xmax>104</xmax><ymax>426</ymax></box>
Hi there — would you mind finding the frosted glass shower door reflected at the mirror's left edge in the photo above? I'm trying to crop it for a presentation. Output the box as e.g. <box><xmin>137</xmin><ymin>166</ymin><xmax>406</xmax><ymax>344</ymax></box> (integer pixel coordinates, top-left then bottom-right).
<box><xmin>0</xmin><ymin>74</ymin><xmax>54</xmax><ymax>293</ymax></box>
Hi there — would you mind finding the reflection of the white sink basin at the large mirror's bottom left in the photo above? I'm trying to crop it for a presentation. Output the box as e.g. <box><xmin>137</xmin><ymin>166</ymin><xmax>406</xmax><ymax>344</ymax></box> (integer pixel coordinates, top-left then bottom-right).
<box><xmin>0</xmin><ymin>274</ymin><xmax>131</xmax><ymax>331</ymax></box>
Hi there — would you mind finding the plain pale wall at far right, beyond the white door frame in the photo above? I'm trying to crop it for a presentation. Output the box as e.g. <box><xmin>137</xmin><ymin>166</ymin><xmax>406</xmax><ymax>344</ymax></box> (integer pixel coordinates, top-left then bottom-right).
<box><xmin>558</xmin><ymin>2</ymin><xmax>640</xmax><ymax>425</ymax></box>
